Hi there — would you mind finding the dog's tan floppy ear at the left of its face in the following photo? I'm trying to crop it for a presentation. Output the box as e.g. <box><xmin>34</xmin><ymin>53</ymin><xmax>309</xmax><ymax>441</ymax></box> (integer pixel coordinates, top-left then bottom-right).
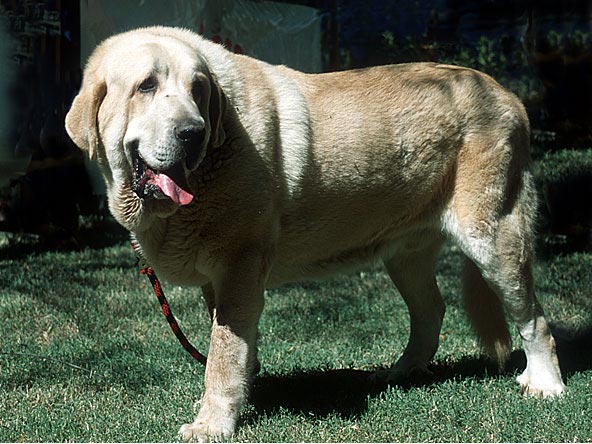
<box><xmin>66</xmin><ymin>82</ymin><xmax>107</xmax><ymax>159</ymax></box>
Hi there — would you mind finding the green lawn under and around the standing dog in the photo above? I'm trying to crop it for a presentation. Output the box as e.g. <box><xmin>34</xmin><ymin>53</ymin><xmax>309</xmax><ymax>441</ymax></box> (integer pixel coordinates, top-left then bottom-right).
<box><xmin>0</xmin><ymin>220</ymin><xmax>592</xmax><ymax>442</ymax></box>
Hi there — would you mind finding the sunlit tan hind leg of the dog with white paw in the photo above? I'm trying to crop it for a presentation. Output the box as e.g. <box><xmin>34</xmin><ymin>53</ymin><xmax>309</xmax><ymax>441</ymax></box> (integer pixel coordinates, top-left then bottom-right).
<box><xmin>443</xmin><ymin>134</ymin><xmax>565</xmax><ymax>397</ymax></box>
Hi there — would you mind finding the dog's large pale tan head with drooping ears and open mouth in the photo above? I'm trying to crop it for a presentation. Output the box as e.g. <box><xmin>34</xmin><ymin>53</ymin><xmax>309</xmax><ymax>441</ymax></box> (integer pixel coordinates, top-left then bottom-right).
<box><xmin>66</xmin><ymin>28</ymin><xmax>225</xmax><ymax>230</ymax></box>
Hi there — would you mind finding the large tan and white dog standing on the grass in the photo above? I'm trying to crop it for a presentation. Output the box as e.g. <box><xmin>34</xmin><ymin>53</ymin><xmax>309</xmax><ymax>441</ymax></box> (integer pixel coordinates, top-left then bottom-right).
<box><xmin>66</xmin><ymin>27</ymin><xmax>564</xmax><ymax>440</ymax></box>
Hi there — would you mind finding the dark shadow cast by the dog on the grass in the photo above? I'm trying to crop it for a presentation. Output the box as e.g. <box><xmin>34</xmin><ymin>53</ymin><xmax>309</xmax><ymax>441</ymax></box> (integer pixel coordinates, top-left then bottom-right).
<box><xmin>251</xmin><ymin>326</ymin><xmax>592</xmax><ymax>418</ymax></box>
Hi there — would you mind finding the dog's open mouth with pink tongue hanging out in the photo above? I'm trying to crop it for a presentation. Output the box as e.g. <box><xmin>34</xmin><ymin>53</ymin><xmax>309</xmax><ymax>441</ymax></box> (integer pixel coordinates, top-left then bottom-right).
<box><xmin>133</xmin><ymin>149</ymin><xmax>193</xmax><ymax>205</ymax></box>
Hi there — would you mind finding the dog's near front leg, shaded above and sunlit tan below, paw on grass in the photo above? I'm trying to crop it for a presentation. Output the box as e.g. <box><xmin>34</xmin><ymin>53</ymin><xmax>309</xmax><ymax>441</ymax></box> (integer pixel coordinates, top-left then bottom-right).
<box><xmin>179</xmin><ymin>259</ymin><xmax>265</xmax><ymax>442</ymax></box>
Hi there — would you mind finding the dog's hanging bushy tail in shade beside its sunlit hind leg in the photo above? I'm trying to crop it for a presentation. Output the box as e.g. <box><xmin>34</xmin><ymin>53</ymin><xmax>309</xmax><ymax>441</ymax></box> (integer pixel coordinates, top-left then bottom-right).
<box><xmin>463</xmin><ymin>258</ymin><xmax>512</xmax><ymax>369</ymax></box>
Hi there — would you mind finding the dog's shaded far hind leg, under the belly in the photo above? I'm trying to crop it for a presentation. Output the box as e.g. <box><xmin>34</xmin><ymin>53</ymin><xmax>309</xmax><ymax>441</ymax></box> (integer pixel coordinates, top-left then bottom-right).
<box><xmin>385</xmin><ymin>239</ymin><xmax>445</xmax><ymax>376</ymax></box>
